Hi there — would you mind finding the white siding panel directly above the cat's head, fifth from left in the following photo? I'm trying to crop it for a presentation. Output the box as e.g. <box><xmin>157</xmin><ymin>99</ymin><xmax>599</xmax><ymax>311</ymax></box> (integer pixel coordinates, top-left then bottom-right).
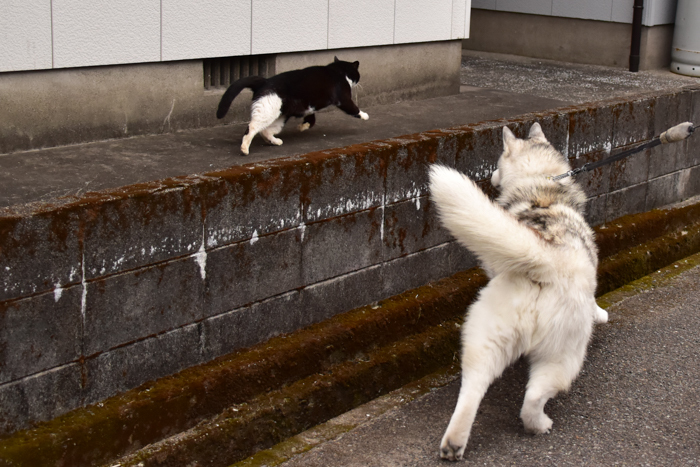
<box><xmin>328</xmin><ymin>0</ymin><xmax>394</xmax><ymax>49</ymax></box>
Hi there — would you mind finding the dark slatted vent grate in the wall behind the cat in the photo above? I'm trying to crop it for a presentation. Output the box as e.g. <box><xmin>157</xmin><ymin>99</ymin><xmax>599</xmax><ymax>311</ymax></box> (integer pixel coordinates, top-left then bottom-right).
<box><xmin>204</xmin><ymin>55</ymin><xmax>275</xmax><ymax>89</ymax></box>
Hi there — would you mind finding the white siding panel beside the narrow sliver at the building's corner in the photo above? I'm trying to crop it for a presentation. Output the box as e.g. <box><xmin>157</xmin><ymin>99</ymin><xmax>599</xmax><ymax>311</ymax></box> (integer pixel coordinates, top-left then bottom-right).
<box><xmin>394</xmin><ymin>0</ymin><xmax>452</xmax><ymax>44</ymax></box>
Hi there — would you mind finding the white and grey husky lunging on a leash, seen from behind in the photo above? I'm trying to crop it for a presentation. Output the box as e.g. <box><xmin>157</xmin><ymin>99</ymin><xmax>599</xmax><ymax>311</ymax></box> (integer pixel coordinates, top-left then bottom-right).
<box><xmin>430</xmin><ymin>123</ymin><xmax>608</xmax><ymax>460</ymax></box>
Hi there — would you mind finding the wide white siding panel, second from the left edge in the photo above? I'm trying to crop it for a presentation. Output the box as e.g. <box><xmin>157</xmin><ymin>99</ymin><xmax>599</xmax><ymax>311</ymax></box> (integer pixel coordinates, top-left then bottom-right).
<box><xmin>53</xmin><ymin>0</ymin><xmax>160</xmax><ymax>68</ymax></box>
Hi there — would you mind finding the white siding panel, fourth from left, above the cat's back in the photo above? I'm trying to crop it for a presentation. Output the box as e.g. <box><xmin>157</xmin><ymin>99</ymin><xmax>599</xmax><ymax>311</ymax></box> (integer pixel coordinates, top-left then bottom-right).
<box><xmin>252</xmin><ymin>0</ymin><xmax>328</xmax><ymax>54</ymax></box>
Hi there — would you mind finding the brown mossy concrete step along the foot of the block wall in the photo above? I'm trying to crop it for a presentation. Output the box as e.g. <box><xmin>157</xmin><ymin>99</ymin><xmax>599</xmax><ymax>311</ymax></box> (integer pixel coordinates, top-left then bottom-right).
<box><xmin>0</xmin><ymin>200</ymin><xmax>700</xmax><ymax>466</ymax></box>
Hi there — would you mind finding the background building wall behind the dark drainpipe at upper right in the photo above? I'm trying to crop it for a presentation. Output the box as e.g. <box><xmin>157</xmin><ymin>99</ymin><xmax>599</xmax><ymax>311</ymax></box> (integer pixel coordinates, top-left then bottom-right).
<box><xmin>464</xmin><ymin>0</ymin><xmax>677</xmax><ymax>70</ymax></box>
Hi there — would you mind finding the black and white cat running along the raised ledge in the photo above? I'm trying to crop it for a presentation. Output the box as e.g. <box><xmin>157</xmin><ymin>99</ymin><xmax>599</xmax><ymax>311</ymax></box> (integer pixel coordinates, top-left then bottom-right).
<box><xmin>216</xmin><ymin>57</ymin><xmax>369</xmax><ymax>155</ymax></box>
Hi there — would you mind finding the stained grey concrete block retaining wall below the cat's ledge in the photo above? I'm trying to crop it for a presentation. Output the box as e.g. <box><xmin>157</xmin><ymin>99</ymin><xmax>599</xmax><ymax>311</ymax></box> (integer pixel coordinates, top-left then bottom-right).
<box><xmin>0</xmin><ymin>90</ymin><xmax>700</xmax><ymax>434</ymax></box>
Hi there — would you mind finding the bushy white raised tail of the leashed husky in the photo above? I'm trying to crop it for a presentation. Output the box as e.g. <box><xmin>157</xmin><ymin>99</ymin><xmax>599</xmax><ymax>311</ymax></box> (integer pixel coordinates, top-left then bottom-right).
<box><xmin>430</xmin><ymin>165</ymin><xmax>555</xmax><ymax>282</ymax></box>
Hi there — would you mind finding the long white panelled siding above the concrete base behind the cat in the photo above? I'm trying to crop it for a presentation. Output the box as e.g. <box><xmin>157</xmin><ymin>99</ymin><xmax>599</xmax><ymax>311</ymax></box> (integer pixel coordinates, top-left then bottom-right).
<box><xmin>0</xmin><ymin>0</ymin><xmax>471</xmax><ymax>72</ymax></box>
